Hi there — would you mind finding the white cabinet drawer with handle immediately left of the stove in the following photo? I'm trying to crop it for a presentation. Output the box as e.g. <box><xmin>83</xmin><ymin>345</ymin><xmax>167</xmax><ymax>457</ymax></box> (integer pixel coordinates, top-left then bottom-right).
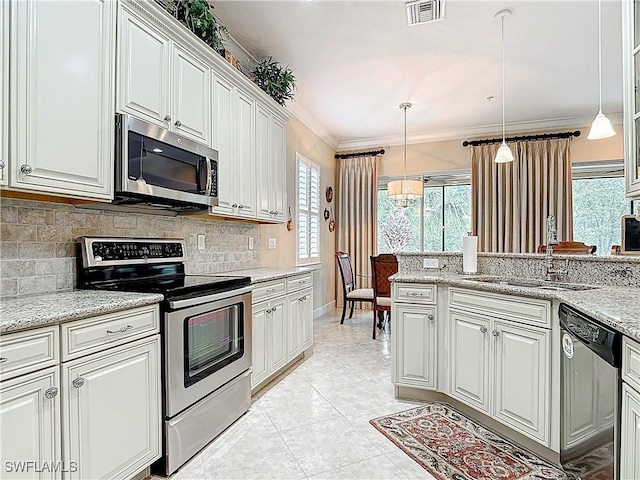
<box><xmin>61</xmin><ymin>305</ymin><xmax>159</xmax><ymax>362</ymax></box>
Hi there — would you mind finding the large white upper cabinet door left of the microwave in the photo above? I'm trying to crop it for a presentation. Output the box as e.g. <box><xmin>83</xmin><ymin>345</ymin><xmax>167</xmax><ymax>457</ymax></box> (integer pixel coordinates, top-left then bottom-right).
<box><xmin>10</xmin><ymin>0</ymin><xmax>116</xmax><ymax>199</ymax></box>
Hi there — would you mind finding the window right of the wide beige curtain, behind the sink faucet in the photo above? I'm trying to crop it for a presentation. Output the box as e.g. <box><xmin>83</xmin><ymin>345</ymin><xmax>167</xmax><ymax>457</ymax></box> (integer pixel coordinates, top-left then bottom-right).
<box><xmin>572</xmin><ymin>162</ymin><xmax>633</xmax><ymax>255</ymax></box>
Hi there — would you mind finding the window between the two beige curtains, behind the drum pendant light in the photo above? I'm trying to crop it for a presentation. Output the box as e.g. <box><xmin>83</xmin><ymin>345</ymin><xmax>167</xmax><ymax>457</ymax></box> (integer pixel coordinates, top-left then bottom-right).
<box><xmin>378</xmin><ymin>171</ymin><xmax>471</xmax><ymax>253</ymax></box>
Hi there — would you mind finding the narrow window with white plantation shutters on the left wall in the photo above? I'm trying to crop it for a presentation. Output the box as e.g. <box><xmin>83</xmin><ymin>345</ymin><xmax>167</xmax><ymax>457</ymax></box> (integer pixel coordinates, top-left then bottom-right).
<box><xmin>296</xmin><ymin>153</ymin><xmax>320</xmax><ymax>265</ymax></box>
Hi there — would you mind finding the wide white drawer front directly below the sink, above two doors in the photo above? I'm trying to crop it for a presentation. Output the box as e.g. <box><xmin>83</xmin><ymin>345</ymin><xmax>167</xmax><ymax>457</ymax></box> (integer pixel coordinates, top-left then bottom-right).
<box><xmin>449</xmin><ymin>288</ymin><xmax>551</xmax><ymax>328</ymax></box>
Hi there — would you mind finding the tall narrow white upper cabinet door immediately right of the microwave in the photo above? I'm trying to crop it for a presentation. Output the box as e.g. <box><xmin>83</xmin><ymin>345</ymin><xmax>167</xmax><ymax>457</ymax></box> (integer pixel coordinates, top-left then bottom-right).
<box><xmin>212</xmin><ymin>76</ymin><xmax>237</xmax><ymax>215</ymax></box>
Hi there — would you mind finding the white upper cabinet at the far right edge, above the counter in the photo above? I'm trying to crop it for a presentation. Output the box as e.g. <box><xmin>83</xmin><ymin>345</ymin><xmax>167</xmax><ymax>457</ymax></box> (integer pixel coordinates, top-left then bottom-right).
<box><xmin>622</xmin><ymin>0</ymin><xmax>640</xmax><ymax>198</ymax></box>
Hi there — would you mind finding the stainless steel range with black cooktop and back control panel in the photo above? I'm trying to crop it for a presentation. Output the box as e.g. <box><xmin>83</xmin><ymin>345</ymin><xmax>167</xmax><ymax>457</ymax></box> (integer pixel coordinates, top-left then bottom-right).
<box><xmin>77</xmin><ymin>237</ymin><xmax>251</xmax><ymax>475</ymax></box>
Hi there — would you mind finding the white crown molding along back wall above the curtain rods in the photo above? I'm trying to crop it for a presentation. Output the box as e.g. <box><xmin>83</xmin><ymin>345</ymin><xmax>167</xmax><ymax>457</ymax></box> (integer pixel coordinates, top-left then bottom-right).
<box><xmin>338</xmin><ymin>113</ymin><xmax>622</xmax><ymax>151</ymax></box>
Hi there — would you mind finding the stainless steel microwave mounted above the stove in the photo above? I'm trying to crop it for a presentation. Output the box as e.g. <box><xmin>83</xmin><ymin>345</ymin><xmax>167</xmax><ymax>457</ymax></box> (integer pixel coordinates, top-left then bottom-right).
<box><xmin>114</xmin><ymin>114</ymin><xmax>218</xmax><ymax>213</ymax></box>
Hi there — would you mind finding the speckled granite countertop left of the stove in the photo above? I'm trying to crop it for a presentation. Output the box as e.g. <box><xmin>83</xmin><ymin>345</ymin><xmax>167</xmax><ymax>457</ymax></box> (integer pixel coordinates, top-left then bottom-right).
<box><xmin>0</xmin><ymin>290</ymin><xmax>164</xmax><ymax>335</ymax></box>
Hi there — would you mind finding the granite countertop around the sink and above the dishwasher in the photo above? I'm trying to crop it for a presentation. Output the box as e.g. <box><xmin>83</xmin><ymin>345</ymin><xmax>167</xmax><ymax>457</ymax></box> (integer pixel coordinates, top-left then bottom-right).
<box><xmin>389</xmin><ymin>272</ymin><xmax>640</xmax><ymax>342</ymax></box>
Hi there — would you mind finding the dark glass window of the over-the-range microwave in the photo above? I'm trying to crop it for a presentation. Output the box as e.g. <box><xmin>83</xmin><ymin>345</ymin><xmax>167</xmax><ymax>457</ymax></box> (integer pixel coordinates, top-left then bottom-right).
<box><xmin>128</xmin><ymin>132</ymin><xmax>207</xmax><ymax>193</ymax></box>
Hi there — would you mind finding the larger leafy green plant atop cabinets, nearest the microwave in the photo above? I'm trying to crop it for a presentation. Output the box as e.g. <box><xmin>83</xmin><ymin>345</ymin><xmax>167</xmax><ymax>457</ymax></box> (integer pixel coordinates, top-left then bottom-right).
<box><xmin>165</xmin><ymin>0</ymin><xmax>229</xmax><ymax>54</ymax></box>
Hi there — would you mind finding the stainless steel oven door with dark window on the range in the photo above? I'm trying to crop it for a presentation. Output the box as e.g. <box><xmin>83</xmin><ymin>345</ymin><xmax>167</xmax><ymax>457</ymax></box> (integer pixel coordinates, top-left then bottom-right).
<box><xmin>163</xmin><ymin>292</ymin><xmax>251</xmax><ymax>418</ymax></box>
